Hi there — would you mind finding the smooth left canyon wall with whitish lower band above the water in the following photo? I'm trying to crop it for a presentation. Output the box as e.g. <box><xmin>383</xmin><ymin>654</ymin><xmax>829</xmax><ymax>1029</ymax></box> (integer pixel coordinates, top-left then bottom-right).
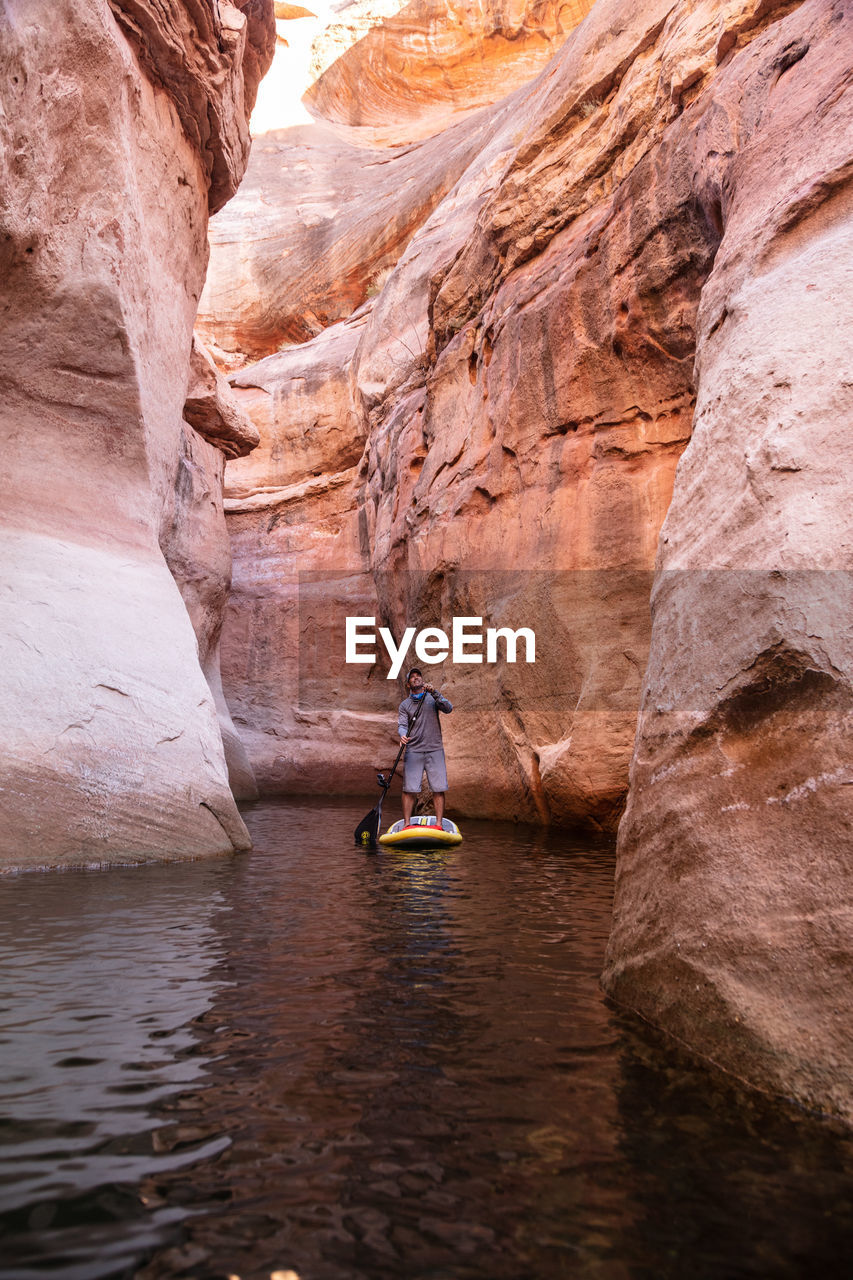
<box><xmin>0</xmin><ymin>0</ymin><xmax>274</xmax><ymax>867</ymax></box>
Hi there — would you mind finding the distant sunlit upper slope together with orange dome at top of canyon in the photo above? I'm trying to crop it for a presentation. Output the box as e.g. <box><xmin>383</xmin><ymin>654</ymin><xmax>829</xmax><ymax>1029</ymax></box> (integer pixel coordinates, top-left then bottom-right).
<box><xmin>199</xmin><ymin>0</ymin><xmax>592</xmax><ymax>367</ymax></box>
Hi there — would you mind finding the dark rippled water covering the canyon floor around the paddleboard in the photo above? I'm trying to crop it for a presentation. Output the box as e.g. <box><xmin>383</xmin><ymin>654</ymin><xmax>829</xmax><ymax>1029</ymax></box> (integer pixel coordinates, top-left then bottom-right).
<box><xmin>0</xmin><ymin>803</ymin><xmax>853</xmax><ymax>1280</ymax></box>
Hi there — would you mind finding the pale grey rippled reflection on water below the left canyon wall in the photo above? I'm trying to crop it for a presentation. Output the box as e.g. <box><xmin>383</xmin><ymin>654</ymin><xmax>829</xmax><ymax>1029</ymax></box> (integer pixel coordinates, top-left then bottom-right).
<box><xmin>0</xmin><ymin>864</ymin><xmax>228</xmax><ymax>1277</ymax></box>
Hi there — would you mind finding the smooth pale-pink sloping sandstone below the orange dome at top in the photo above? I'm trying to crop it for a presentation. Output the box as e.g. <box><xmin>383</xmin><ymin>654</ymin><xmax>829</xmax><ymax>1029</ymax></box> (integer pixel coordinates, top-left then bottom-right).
<box><xmin>197</xmin><ymin>110</ymin><xmax>499</xmax><ymax>364</ymax></box>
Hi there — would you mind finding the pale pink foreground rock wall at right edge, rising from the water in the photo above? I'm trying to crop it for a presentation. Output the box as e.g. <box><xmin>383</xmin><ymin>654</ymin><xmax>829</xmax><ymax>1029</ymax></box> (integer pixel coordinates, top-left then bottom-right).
<box><xmin>605</xmin><ymin>3</ymin><xmax>853</xmax><ymax>1119</ymax></box>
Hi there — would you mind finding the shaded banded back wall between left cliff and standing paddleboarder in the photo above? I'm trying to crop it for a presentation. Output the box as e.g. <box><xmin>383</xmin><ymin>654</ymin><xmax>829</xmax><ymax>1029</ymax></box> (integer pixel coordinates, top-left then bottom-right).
<box><xmin>223</xmin><ymin>308</ymin><xmax>389</xmax><ymax>794</ymax></box>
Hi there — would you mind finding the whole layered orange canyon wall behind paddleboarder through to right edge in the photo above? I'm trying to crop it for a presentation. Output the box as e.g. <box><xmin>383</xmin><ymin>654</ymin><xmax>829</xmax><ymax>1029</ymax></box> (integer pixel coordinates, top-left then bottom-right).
<box><xmin>202</xmin><ymin>0</ymin><xmax>853</xmax><ymax>1119</ymax></box>
